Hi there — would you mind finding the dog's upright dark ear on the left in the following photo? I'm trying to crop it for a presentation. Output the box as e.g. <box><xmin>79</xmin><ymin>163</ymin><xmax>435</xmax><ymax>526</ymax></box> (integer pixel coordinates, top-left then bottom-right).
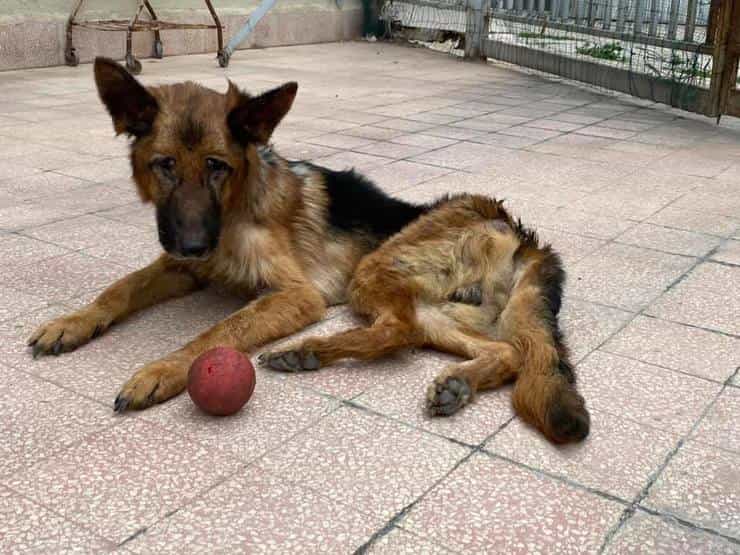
<box><xmin>95</xmin><ymin>58</ymin><xmax>159</xmax><ymax>137</ymax></box>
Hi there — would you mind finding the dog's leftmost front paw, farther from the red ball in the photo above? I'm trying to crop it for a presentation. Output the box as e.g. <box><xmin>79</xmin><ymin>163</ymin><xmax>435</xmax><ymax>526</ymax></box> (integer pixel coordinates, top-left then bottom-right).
<box><xmin>28</xmin><ymin>310</ymin><xmax>110</xmax><ymax>358</ymax></box>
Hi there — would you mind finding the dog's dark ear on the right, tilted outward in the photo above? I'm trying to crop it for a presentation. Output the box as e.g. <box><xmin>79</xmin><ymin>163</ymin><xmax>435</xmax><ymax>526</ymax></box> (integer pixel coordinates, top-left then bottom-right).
<box><xmin>227</xmin><ymin>82</ymin><xmax>298</xmax><ymax>145</ymax></box>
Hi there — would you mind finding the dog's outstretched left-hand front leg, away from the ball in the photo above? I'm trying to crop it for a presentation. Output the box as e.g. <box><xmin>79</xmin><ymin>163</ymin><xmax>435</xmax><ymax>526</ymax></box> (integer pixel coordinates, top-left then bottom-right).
<box><xmin>28</xmin><ymin>255</ymin><xmax>199</xmax><ymax>357</ymax></box>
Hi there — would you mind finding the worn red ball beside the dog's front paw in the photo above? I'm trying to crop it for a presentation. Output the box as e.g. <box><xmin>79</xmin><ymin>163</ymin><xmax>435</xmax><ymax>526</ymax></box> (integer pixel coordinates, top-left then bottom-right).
<box><xmin>188</xmin><ymin>347</ymin><xmax>255</xmax><ymax>416</ymax></box>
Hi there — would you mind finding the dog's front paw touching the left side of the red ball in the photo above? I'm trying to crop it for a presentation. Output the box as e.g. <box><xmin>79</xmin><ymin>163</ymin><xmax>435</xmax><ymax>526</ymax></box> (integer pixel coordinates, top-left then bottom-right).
<box><xmin>113</xmin><ymin>359</ymin><xmax>188</xmax><ymax>413</ymax></box>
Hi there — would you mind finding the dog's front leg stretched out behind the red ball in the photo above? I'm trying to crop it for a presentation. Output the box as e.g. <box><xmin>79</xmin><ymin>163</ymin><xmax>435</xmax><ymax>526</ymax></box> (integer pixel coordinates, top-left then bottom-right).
<box><xmin>114</xmin><ymin>284</ymin><xmax>326</xmax><ymax>412</ymax></box>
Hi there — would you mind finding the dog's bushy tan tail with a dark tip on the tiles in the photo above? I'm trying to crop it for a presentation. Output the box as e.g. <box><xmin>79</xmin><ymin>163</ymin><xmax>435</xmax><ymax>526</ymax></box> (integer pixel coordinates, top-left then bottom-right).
<box><xmin>497</xmin><ymin>243</ymin><xmax>590</xmax><ymax>443</ymax></box>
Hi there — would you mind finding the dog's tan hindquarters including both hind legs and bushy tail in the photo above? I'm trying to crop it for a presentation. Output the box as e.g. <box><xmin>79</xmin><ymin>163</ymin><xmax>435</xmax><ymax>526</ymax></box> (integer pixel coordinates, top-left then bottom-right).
<box><xmin>263</xmin><ymin>196</ymin><xmax>588</xmax><ymax>442</ymax></box>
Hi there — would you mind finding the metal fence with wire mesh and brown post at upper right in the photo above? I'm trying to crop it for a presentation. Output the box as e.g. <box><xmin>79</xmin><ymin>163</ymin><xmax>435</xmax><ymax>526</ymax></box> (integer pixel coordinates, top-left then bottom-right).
<box><xmin>381</xmin><ymin>0</ymin><xmax>740</xmax><ymax>116</ymax></box>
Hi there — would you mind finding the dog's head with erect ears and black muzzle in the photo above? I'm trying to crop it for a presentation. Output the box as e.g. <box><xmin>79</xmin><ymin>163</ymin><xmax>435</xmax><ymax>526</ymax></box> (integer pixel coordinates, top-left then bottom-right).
<box><xmin>95</xmin><ymin>58</ymin><xmax>298</xmax><ymax>259</ymax></box>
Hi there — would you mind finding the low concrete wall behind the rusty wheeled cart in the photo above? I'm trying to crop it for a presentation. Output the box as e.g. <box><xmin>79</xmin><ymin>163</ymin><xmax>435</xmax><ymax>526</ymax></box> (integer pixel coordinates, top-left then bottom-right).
<box><xmin>0</xmin><ymin>0</ymin><xmax>362</xmax><ymax>70</ymax></box>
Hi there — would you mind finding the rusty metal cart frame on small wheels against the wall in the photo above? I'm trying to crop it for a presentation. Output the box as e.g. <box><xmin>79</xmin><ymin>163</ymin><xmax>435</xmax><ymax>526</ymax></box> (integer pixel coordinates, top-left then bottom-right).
<box><xmin>64</xmin><ymin>0</ymin><xmax>229</xmax><ymax>74</ymax></box>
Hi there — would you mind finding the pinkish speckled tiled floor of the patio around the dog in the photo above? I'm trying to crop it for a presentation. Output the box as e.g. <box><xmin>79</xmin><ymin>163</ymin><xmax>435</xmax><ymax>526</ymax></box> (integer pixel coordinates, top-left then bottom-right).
<box><xmin>0</xmin><ymin>43</ymin><xmax>740</xmax><ymax>554</ymax></box>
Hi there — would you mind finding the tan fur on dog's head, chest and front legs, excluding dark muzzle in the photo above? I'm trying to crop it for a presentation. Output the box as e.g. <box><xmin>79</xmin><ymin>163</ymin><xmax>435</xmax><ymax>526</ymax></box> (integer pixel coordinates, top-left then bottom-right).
<box><xmin>30</xmin><ymin>61</ymin><xmax>372</xmax><ymax>410</ymax></box>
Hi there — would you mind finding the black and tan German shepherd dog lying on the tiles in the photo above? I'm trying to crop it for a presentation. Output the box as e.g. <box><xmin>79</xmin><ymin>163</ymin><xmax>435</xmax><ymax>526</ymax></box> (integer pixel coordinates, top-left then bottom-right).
<box><xmin>29</xmin><ymin>58</ymin><xmax>589</xmax><ymax>442</ymax></box>
